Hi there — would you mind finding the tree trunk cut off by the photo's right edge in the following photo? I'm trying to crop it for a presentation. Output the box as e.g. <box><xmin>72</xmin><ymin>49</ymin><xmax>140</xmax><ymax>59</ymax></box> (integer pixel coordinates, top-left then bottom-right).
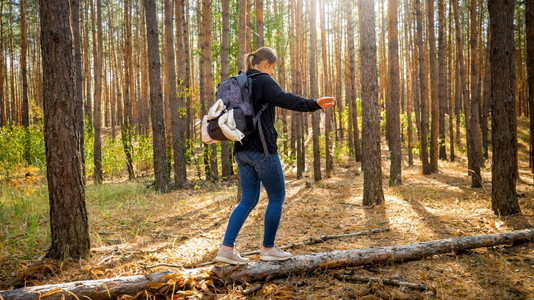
<box><xmin>525</xmin><ymin>1</ymin><xmax>534</xmax><ymax>175</ymax></box>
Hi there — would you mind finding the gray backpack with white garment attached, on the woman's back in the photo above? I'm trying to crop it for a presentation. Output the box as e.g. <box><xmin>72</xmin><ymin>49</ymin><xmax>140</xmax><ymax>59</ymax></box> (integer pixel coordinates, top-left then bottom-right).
<box><xmin>205</xmin><ymin>71</ymin><xmax>269</xmax><ymax>157</ymax></box>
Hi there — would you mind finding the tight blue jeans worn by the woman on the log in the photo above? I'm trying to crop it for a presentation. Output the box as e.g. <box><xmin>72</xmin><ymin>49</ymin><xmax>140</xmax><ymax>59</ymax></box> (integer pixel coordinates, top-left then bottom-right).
<box><xmin>223</xmin><ymin>152</ymin><xmax>286</xmax><ymax>248</ymax></box>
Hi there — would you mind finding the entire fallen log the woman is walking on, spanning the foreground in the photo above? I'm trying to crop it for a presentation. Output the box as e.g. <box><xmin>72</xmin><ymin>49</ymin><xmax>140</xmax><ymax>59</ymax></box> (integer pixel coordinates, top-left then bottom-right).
<box><xmin>0</xmin><ymin>229</ymin><xmax>534</xmax><ymax>300</ymax></box>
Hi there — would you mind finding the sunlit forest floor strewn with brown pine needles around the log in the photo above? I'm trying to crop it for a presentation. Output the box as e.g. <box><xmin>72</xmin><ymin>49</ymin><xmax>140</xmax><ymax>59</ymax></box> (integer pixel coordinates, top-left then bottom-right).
<box><xmin>0</xmin><ymin>121</ymin><xmax>534</xmax><ymax>299</ymax></box>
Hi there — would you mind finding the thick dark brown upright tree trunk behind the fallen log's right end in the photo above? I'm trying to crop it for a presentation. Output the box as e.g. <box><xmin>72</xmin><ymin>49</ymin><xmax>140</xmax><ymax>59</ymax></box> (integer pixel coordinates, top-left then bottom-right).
<box><xmin>488</xmin><ymin>0</ymin><xmax>521</xmax><ymax>216</ymax></box>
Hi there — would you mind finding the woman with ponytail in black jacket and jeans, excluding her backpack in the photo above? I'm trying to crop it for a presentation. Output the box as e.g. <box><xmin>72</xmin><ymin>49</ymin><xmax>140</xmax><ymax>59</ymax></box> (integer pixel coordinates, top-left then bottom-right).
<box><xmin>215</xmin><ymin>47</ymin><xmax>334</xmax><ymax>265</ymax></box>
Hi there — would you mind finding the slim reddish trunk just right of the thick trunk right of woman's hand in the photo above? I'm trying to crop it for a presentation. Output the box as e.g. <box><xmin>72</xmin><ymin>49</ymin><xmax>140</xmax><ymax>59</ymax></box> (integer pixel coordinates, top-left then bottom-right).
<box><xmin>386</xmin><ymin>0</ymin><xmax>402</xmax><ymax>186</ymax></box>
